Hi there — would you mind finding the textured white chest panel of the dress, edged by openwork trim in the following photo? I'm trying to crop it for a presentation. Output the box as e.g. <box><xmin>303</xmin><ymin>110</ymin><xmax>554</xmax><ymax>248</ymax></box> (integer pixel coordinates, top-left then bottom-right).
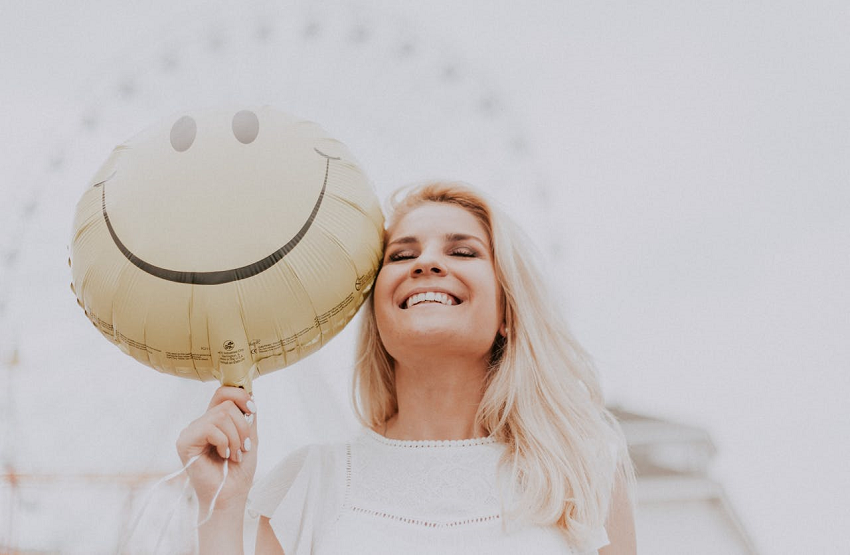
<box><xmin>346</xmin><ymin>430</ymin><xmax>504</xmax><ymax>528</ymax></box>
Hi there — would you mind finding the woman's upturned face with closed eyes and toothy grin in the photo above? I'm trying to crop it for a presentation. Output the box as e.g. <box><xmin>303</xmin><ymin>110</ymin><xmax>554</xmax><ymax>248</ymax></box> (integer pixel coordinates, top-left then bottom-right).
<box><xmin>374</xmin><ymin>202</ymin><xmax>504</xmax><ymax>361</ymax></box>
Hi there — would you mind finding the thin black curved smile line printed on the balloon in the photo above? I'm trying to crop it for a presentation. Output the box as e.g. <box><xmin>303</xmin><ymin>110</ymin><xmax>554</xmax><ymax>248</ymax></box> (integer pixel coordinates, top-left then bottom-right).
<box><xmin>94</xmin><ymin>147</ymin><xmax>339</xmax><ymax>285</ymax></box>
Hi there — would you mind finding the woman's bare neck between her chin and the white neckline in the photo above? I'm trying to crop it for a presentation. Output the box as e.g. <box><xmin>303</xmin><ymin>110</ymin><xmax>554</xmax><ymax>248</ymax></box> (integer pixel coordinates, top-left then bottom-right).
<box><xmin>377</xmin><ymin>356</ymin><xmax>488</xmax><ymax>440</ymax></box>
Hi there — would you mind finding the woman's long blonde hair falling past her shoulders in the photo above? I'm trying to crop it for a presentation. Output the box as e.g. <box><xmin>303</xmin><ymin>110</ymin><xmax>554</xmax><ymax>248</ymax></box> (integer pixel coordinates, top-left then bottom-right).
<box><xmin>354</xmin><ymin>182</ymin><xmax>634</xmax><ymax>546</ymax></box>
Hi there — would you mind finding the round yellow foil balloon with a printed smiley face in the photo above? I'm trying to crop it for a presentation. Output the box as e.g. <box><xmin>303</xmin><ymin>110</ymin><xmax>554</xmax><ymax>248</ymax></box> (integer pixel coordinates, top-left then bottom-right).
<box><xmin>71</xmin><ymin>107</ymin><xmax>383</xmax><ymax>390</ymax></box>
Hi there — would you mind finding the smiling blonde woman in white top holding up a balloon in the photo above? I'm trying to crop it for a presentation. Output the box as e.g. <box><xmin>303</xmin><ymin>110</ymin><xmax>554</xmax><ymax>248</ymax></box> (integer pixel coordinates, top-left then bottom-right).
<box><xmin>177</xmin><ymin>183</ymin><xmax>636</xmax><ymax>555</ymax></box>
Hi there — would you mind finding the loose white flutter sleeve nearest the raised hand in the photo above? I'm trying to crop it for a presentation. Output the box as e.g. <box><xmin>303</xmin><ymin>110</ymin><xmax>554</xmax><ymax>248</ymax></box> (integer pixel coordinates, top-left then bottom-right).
<box><xmin>248</xmin><ymin>445</ymin><xmax>345</xmax><ymax>555</ymax></box>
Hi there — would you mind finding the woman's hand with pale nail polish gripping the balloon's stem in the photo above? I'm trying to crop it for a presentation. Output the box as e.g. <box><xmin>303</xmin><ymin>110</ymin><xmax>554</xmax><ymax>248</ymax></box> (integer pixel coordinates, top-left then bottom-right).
<box><xmin>177</xmin><ymin>386</ymin><xmax>257</xmax><ymax>518</ymax></box>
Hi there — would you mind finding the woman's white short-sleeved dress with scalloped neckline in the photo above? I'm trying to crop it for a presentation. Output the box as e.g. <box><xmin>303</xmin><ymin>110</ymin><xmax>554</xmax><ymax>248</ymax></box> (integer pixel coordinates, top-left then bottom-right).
<box><xmin>248</xmin><ymin>429</ymin><xmax>608</xmax><ymax>555</ymax></box>
